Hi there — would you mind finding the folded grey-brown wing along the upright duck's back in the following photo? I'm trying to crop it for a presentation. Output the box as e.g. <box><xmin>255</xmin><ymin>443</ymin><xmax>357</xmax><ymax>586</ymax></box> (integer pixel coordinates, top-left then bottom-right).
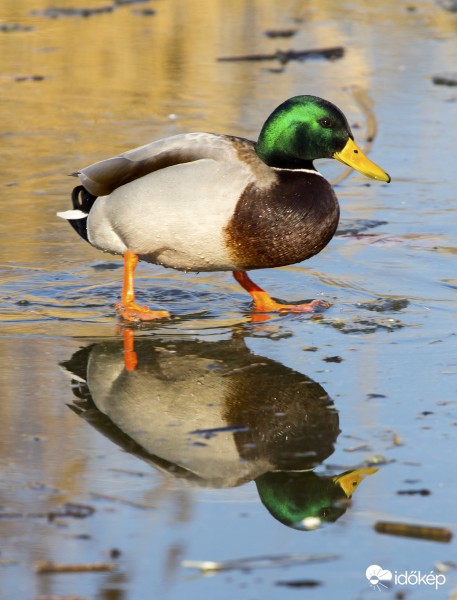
<box><xmin>77</xmin><ymin>133</ymin><xmax>249</xmax><ymax>196</ymax></box>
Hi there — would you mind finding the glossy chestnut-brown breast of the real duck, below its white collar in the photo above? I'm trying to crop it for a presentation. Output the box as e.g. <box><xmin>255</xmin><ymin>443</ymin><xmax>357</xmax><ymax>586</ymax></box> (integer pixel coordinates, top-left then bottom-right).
<box><xmin>225</xmin><ymin>170</ymin><xmax>339</xmax><ymax>270</ymax></box>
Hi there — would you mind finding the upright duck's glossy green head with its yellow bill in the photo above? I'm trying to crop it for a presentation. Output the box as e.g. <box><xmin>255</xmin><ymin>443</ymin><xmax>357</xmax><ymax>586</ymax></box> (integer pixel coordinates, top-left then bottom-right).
<box><xmin>256</xmin><ymin>96</ymin><xmax>390</xmax><ymax>182</ymax></box>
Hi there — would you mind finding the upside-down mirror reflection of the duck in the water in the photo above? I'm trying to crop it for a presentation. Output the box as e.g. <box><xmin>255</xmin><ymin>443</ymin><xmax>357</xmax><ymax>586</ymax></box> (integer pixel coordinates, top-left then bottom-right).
<box><xmin>62</xmin><ymin>329</ymin><xmax>376</xmax><ymax>528</ymax></box>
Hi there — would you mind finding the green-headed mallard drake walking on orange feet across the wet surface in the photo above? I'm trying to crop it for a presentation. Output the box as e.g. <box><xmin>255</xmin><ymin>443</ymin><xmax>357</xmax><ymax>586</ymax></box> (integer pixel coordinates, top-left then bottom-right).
<box><xmin>58</xmin><ymin>96</ymin><xmax>390</xmax><ymax>321</ymax></box>
